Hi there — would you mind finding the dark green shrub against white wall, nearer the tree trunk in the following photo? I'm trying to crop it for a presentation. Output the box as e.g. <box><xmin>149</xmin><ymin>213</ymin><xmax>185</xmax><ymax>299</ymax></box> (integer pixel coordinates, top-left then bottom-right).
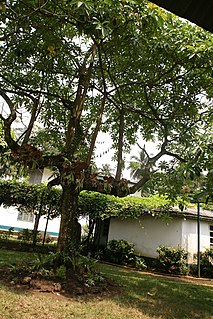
<box><xmin>108</xmin><ymin>239</ymin><xmax>135</xmax><ymax>265</ymax></box>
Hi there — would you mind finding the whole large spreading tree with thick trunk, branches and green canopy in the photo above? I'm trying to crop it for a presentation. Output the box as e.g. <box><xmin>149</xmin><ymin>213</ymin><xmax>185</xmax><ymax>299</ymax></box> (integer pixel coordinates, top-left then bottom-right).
<box><xmin>0</xmin><ymin>0</ymin><xmax>212</xmax><ymax>258</ymax></box>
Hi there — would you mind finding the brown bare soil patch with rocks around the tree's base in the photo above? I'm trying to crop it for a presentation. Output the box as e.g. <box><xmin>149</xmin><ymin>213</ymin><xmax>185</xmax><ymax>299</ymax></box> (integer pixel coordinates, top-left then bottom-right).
<box><xmin>0</xmin><ymin>267</ymin><xmax>121</xmax><ymax>299</ymax></box>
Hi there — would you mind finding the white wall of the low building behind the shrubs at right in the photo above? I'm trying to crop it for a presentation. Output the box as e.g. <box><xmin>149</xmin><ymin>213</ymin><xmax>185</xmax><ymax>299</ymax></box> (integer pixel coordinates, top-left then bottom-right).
<box><xmin>108</xmin><ymin>216</ymin><xmax>213</xmax><ymax>263</ymax></box>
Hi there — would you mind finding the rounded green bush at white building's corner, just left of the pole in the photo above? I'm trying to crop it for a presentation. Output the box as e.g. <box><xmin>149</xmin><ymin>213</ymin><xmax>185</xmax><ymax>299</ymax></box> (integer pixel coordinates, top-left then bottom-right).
<box><xmin>157</xmin><ymin>246</ymin><xmax>188</xmax><ymax>275</ymax></box>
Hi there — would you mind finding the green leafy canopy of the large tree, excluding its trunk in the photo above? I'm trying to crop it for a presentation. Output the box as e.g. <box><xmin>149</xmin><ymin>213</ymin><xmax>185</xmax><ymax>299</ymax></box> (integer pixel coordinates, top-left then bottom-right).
<box><xmin>0</xmin><ymin>0</ymin><xmax>212</xmax><ymax>188</ymax></box>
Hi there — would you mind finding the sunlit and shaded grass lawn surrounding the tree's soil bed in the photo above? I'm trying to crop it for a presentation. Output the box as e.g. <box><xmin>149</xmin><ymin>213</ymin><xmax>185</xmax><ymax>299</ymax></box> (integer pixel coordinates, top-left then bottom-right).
<box><xmin>0</xmin><ymin>250</ymin><xmax>213</xmax><ymax>319</ymax></box>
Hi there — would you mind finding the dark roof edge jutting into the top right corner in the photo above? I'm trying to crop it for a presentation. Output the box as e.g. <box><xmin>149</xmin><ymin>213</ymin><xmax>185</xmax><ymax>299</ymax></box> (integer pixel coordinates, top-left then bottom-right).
<box><xmin>151</xmin><ymin>0</ymin><xmax>213</xmax><ymax>32</ymax></box>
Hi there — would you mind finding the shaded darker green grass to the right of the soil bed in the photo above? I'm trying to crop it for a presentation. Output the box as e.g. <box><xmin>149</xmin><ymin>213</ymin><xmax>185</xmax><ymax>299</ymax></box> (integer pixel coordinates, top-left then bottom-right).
<box><xmin>100</xmin><ymin>265</ymin><xmax>213</xmax><ymax>319</ymax></box>
